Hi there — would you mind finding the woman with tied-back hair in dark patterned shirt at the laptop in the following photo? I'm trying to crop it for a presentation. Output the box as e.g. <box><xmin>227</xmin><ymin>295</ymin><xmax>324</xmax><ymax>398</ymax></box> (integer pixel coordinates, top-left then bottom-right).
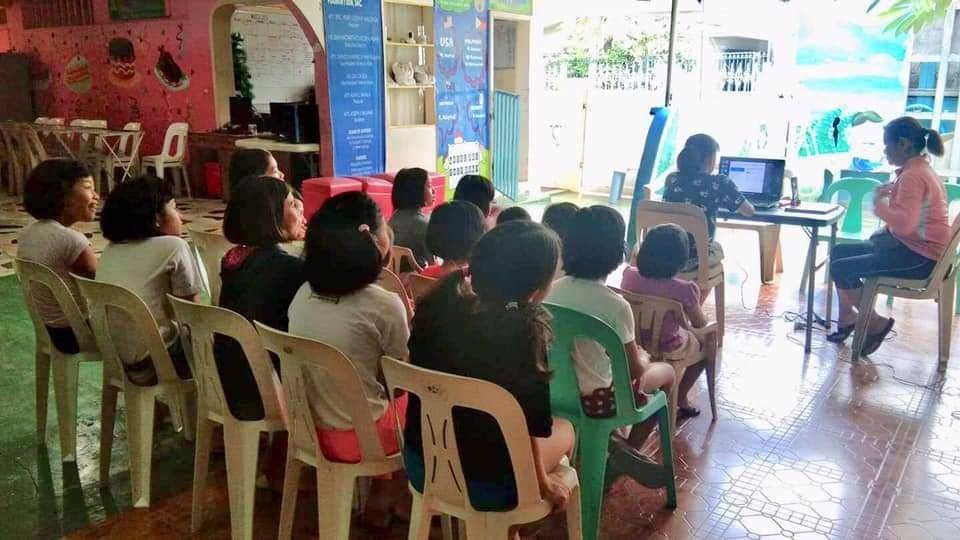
<box><xmin>663</xmin><ymin>133</ymin><xmax>753</xmax><ymax>274</ymax></box>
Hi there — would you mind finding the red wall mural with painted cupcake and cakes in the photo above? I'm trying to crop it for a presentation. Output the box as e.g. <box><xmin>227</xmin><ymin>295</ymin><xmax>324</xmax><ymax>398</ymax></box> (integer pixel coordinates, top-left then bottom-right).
<box><xmin>22</xmin><ymin>19</ymin><xmax>209</xmax><ymax>154</ymax></box>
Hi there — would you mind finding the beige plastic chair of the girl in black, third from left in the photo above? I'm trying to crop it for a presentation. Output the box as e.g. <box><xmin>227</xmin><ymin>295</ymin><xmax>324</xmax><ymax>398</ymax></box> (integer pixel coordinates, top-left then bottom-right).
<box><xmin>167</xmin><ymin>295</ymin><xmax>287</xmax><ymax>540</ymax></box>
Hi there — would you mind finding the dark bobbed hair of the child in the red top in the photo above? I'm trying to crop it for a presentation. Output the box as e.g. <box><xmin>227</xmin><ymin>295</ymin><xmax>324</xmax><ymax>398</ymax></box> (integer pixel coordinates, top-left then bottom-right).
<box><xmin>427</xmin><ymin>201</ymin><xmax>485</xmax><ymax>261</ymax></box>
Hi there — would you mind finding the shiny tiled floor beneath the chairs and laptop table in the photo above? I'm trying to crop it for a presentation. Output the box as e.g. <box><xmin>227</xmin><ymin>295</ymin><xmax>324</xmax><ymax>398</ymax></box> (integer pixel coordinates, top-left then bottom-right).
<box><xmin>0</xmin><ymin>193</ymin><xmax>960</xmax><ymax>540</ymax></box>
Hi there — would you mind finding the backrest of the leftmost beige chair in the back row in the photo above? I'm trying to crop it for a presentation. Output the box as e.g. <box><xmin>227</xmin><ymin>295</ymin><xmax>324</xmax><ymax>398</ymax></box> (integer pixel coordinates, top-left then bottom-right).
<box><xmin>13</xmin><ymin>259</ymin><xmax>97</xmax><ymax>351</ymax></box>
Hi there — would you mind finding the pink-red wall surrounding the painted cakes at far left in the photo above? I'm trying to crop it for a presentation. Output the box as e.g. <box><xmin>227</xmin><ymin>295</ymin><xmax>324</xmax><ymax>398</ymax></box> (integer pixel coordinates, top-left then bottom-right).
<box><xmin>7</xmin><ymin>0</ymin><xmax>216</xmax><ymax>153</ymax></box>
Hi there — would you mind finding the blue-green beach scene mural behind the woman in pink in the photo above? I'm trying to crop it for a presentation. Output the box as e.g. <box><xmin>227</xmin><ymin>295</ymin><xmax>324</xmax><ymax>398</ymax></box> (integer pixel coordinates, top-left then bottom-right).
<box><xmin>796</xmin><ymin>0</ymin><xmax>909</xmax><ymax>171</ymax></box>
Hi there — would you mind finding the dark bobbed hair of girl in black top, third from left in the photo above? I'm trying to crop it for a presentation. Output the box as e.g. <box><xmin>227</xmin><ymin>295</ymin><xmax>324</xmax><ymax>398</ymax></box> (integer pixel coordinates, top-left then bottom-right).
<box><xmin>223</xmin><ymin>176</ymin><xmax>293</xmax><ymax>247</ymax></box>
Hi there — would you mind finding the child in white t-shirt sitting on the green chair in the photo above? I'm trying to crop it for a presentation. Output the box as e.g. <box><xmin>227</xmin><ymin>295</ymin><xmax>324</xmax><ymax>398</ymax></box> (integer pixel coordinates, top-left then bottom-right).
<box><xmin>547</xmin><ymin>206</ymin><xmax>674</xmax><ymax>449</ymax></box>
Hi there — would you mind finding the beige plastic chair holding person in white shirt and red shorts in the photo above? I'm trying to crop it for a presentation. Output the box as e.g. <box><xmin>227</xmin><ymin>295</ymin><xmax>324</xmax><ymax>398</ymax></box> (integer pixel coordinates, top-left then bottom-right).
<box><xmin>254</xmin><ymin>322</ymin><xmax>403</xmax><ymax>540</ymax></box>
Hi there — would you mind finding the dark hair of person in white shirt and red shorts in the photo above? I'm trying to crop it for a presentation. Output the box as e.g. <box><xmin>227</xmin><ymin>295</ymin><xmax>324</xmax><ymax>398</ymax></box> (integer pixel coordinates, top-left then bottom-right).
<box><xmin>303</xmin><ymin>191</ymin><xmax>385</xmax><ymax>296</ymax></box>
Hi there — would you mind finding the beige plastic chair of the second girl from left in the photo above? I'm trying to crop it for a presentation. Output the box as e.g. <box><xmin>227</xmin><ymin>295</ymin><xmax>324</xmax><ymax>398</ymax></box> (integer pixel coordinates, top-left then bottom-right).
<box><xmin>71</xmin><ymin>274</ymin><xmax>196</xmax><ymax>508</ymax></box>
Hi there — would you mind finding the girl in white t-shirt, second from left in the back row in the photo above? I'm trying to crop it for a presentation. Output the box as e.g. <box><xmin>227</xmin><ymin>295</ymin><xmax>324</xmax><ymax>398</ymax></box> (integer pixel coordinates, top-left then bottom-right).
<box><xmin>97</xmin><ymin>176</ymin><xmax>200</xmax><ymax>385</ymax></box>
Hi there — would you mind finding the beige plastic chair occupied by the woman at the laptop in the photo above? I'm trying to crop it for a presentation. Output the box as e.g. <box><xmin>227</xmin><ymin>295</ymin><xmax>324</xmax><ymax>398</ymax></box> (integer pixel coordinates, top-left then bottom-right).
<box><xmin>637</xmin><ymin>201</ymin><xmax>725</xmax><ymax>345</ymax></box>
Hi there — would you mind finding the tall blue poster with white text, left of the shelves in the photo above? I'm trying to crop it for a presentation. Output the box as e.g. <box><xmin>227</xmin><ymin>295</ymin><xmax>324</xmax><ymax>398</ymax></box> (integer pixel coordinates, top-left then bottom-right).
<box><xmin>323</xmin><ymin>0</ymin><xmax>386</xmax><ymax>176</ymax></box>
